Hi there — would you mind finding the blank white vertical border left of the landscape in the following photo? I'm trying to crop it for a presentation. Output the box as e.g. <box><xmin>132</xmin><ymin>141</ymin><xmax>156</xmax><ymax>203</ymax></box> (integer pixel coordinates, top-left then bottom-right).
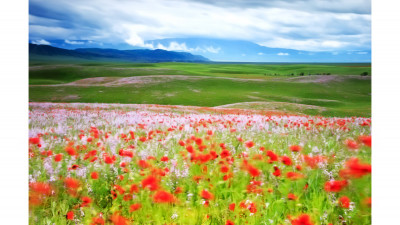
<box><xmin>0</xmin><ymin>1</ymin><xmax>29</xmax><ymax>224</ymax></box>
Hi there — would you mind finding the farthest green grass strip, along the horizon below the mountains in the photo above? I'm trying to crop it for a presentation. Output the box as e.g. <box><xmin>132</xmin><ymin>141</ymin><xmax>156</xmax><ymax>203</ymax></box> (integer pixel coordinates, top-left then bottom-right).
<box><xmin>29</xmin><ymin>62</ymin><xmax>371</xmax><ymax>84</ymax></box>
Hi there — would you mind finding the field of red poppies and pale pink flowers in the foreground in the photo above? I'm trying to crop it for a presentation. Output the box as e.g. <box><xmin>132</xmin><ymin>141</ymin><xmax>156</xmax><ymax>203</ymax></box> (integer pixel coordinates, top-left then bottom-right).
<box><xmin>29</xmin><ymin>102</ymin><xmax>371</xmax><ymax>225</ymax></box>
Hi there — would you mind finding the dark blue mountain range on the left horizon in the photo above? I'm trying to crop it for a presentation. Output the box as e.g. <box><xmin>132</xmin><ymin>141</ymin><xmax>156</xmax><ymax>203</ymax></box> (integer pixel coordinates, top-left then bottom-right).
<box><xmin>29</xmin><ymin>44</ymin><xmax>210</xmax><ymax>62</ymax></box>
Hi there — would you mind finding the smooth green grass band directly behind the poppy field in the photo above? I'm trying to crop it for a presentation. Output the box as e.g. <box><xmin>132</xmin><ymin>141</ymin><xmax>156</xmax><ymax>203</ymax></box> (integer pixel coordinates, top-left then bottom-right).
<box><xmin>29</xmin><ymin>78</ymin><xmax>371</xmax><ymax>116</ymax></box>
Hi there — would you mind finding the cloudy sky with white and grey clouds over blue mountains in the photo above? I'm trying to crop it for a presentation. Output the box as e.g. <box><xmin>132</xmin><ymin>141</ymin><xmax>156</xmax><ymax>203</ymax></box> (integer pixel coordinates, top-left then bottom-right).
<box><xmin>29</xmin><ymin>0</ymin><xmax>371</xmax><ymax>61</ymax></box>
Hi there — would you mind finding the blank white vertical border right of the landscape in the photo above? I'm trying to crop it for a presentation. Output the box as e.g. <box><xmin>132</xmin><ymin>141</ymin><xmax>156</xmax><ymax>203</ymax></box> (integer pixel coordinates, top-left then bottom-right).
<box><xmin>372</xmin><ymin>0</ymin><xmax>400</xmax><ymax>222</ymax></box>
